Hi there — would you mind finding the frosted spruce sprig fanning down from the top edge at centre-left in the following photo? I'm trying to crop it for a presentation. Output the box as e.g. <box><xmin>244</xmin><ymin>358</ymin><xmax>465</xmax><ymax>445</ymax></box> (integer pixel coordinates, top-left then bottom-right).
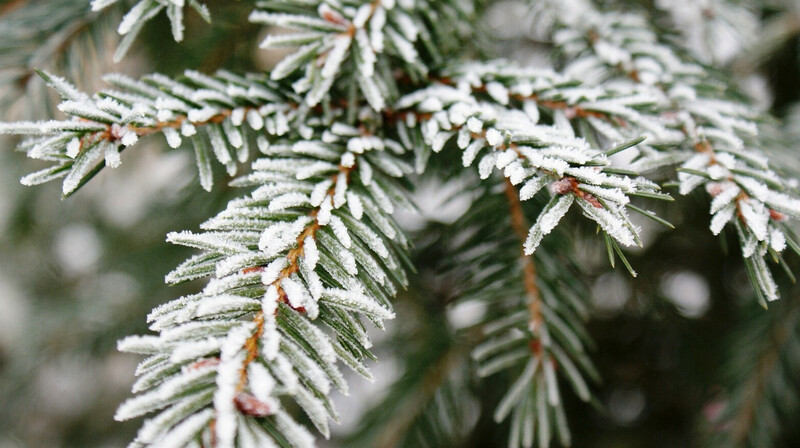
<box><xmin>250</xmin><ymin>0</ymin><xmax>463</xmax><ymax>111</ymax></box>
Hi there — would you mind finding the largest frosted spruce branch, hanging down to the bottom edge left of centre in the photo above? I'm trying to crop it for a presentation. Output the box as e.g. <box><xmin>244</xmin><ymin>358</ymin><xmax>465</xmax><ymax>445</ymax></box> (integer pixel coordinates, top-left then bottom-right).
<box><xmin>117</xmin><ymin>124</ymin><xmax>410</xmax><ymax>447</ymax></box>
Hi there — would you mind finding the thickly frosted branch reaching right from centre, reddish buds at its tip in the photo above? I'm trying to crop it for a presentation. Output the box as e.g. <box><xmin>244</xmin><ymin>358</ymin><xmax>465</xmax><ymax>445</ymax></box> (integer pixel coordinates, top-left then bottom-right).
<box><xmin>395</xmin><ymin>63</ymin><xmax>671</xmax><ymax>255</ymax></box>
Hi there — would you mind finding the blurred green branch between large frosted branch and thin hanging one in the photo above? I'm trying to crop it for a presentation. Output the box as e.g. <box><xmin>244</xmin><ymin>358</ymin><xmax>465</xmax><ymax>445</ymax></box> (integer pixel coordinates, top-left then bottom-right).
<box><xmin>340</xmin><ymin>276</ymin><xmax>480</xmax><ymax>448</ymax></box>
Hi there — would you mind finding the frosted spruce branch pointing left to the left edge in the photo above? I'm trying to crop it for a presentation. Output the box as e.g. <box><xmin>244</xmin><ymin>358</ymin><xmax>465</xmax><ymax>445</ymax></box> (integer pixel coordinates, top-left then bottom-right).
<box><xmin>0</xmin><ymin>71</ymin><xmax>307</xmax><ymax>195</ymax></box>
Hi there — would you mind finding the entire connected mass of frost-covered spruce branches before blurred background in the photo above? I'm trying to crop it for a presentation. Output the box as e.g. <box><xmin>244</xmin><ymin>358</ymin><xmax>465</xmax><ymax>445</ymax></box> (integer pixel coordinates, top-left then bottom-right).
<box><xmin>0</xmin><ymin>0</ymin><xmax>800</xmax><ymax>448</ymax></box>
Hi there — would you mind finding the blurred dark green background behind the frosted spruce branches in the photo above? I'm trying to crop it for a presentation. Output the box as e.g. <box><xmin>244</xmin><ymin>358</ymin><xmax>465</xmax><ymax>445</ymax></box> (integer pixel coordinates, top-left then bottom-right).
<box><xmin>0</xmin><ymin>0</ymin><xmax>800</xmax><ymax>448</ymax></box>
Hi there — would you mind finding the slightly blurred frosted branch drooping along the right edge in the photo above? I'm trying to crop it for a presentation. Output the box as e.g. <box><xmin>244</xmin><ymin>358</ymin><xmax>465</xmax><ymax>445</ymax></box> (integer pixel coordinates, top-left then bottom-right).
<box><xmin>536</xmin><ymin>0</ymin><xmax>800</xmax><ymax>307</ymax></box>
